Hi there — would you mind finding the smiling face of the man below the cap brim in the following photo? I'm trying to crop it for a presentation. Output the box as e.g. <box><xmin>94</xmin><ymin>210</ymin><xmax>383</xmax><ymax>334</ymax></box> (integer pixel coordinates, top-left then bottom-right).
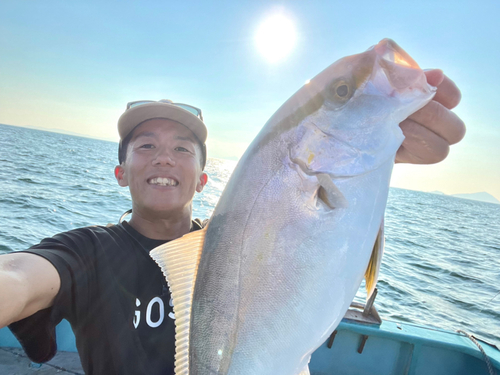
<box><xmin>115</xmin><ymin>119</ymin><xmax>207</xmax><ymax>219</ymax></box>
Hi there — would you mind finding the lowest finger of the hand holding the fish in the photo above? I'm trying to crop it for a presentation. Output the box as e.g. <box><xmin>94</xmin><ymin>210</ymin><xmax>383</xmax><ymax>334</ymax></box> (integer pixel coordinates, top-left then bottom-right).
<box><xmin>396</xmin><ymin>119</ymin><xmax>450</xmax><ymax>164</ymax></box>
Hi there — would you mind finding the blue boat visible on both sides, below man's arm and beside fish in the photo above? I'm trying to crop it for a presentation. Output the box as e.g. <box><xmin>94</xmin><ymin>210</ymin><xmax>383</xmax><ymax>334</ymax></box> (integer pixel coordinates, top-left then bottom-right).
<box><xmin>0</xmin><ymin>293</ymin><xmax>500</xmax><ymax>375</ymax></box>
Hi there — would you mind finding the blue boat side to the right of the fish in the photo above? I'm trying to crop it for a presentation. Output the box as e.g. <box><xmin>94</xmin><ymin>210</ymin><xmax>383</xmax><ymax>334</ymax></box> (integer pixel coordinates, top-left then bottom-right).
<box><xmin>309</xmin><ymin>302</ymin><xmax>500</xmax><ymax>375</ymax></box>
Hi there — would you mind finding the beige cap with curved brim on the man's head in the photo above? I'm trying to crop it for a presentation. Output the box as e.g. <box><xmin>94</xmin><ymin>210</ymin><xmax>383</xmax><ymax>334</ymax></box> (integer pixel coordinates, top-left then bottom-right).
<box><xmin>118</xmin><ymin>102</ymin><xmax>208</xmax><ymax>145</ymax></box>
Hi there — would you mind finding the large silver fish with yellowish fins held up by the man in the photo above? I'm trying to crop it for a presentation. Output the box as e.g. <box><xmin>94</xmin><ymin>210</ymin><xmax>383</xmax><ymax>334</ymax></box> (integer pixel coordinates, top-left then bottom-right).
<box><xmin>150</xmin><ymin>39</ymin><xmax>436</xmax><ymax>375</ymax></box>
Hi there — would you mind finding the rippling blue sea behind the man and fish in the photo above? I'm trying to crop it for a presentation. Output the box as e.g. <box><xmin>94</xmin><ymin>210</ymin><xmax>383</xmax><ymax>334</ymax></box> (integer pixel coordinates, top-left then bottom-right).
<box><xmin>0</xmin><ymin>125</ymin><xmax>500</xmax><ymax>347</ymax></box>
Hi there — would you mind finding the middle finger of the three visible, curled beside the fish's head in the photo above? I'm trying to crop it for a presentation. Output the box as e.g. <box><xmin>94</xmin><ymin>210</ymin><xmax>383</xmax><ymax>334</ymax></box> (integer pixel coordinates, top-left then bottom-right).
<box><xmin>401</xmin><ymin>100</ymin><xmax>465</xmax><ymax>145</ymax></box>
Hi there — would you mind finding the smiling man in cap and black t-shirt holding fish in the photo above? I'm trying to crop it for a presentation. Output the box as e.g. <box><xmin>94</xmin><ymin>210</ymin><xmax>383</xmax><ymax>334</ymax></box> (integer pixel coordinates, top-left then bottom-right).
<box><xmin>0</xmin><ymin>70</ymin><xmax>465</xmax><ymax>374</ymax></box>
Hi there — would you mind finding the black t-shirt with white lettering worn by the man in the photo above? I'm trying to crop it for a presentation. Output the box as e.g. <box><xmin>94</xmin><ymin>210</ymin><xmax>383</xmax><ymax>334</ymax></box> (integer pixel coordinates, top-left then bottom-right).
<box><xmin>10</xmin><ymin>221</ymin><xmax>201</xmax><ymax>375</ymax></box>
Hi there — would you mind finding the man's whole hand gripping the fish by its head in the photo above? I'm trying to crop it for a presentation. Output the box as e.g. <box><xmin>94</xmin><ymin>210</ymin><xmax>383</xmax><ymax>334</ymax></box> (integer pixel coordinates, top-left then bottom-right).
<box><xmin>396</xmin><ymin>69</ymin><xmax>465</xmax><ymax>164</ymax></box>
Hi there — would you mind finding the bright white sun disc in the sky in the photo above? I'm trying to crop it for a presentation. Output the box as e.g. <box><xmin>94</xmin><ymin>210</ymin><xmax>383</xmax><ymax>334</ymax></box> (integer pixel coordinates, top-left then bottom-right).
<box><xmin>255</xmin><ymin>13</ymin><xmax>297</xmax><ymax>63</ymax></box>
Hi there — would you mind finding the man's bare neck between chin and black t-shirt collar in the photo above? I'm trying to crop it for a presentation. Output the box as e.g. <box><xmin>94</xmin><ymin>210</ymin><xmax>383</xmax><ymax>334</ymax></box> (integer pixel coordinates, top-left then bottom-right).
<box><xmin>129</xmin><ymin>210</ymin><xmax>191</xmax><ymax>240</ymax></box>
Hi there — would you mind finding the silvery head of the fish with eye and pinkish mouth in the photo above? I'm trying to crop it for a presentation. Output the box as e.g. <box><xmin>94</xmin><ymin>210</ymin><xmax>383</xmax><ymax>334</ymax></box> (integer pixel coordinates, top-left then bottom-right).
<box><xmin>291</xmin><ymin>39</ymin><xmax>436</xmax><ymax>177</ymax></box>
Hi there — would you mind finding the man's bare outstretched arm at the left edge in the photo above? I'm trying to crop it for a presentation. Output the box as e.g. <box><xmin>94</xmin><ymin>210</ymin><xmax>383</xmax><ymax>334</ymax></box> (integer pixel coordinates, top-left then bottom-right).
<box><xmin>0</xmin><ymin>253</ymin><xmax>61</xmax><ymax>328</ymax></box>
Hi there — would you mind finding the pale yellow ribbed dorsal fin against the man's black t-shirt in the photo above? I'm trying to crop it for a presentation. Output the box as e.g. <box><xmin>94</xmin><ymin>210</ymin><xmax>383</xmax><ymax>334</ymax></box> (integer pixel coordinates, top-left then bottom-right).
<box><xmin>149</xmin><ymin>227</ymin><xmax>207</xmax><ymax>375</ymax></box>
